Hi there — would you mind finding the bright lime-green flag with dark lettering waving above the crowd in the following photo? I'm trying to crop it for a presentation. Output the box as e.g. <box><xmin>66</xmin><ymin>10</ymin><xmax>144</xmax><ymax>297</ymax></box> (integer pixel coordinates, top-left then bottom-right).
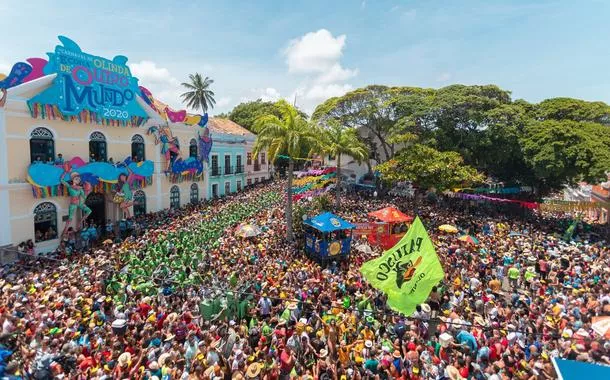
<box><xmin>360</xmin><ymin>217</ymin><xmax>445</xmax><ymax>315</ymax></box>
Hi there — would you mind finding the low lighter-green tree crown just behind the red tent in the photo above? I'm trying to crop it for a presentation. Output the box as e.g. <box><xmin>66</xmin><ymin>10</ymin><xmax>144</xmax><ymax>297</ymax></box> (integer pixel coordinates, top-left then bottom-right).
<box><xmin>377</xmin><ymin>144</ymin><xmax>484</xmax><ymax>191</ymax></box>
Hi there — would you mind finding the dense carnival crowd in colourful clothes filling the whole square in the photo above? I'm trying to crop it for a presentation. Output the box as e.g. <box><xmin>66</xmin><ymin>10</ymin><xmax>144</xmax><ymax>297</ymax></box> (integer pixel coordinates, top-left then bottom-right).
<box><xmin>0</xmin><ymin>180</ymin><xmax>610</xmax><ymax>380</ymax></box>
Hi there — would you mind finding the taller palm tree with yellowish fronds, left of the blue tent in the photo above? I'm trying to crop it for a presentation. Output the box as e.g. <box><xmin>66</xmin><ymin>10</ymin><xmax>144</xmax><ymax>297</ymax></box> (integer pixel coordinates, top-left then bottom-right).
<box><xmin>253</xmin><ymin>100</ymin><xmax>316</xmax><ymax>241</ymax></box>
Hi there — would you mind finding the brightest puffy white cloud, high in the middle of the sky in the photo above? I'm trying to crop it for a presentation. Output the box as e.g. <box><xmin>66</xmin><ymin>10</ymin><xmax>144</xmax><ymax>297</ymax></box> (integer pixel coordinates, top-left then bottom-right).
<box><xmin>284</xmin><ymin>29</ymin><xmax>346</xmax><ymax>73</ymax></box>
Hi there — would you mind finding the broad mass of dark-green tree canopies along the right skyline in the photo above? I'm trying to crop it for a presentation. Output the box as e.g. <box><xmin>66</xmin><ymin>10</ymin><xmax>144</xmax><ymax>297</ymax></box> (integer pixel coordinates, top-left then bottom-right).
<box><xmin>312</xmin><ymin>85</ymin><xmax>610</xmax><ymax>192</ymax></box>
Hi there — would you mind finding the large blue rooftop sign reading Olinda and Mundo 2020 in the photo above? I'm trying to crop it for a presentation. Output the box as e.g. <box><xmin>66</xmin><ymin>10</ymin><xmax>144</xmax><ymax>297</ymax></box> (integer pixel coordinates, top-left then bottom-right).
<box><xmin>28</xmin><ymin>36</ymin><xmax>148</xmax><ymax>121</ymax></box>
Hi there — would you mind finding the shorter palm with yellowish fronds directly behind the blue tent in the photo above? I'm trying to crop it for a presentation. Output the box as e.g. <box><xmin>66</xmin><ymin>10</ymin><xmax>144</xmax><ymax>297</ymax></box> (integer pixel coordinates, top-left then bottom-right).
<box><xmin>318</xmin><ymin>122</ymin><xmax>369</xmax><ymax>209</ymax></box>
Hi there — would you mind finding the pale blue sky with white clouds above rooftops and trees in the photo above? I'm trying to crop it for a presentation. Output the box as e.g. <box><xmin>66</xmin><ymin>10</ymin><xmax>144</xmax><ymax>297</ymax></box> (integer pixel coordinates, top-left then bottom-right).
<box><xmin>0</xmin><ymin>0</ymin><xmax>610</xmax><ymax>114</ymax></box>
